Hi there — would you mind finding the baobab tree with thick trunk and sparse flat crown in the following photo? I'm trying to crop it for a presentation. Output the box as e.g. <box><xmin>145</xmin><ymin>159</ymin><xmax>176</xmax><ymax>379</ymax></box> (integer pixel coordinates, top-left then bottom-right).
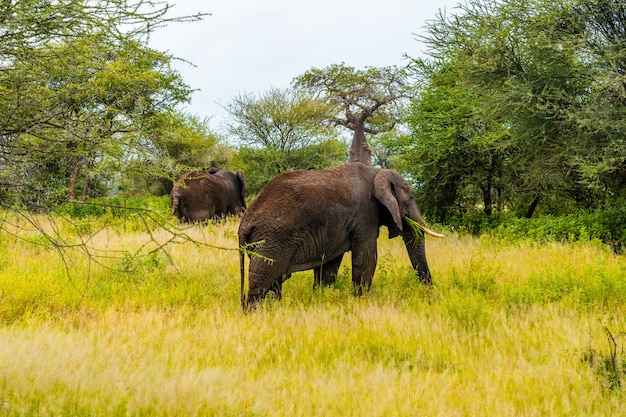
<box><xmin>293</xmin><ymin>64</ymin><xmax>410</xmax><ymax>165</ymax></box>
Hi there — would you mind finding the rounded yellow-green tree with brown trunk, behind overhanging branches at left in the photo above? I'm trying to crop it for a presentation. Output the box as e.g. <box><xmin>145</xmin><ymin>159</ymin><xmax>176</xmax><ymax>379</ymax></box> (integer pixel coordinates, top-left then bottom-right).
<box><xmin>52</xmin><ymin>35</ymin><xmax>192</xmax><ymax>200</ymax></box>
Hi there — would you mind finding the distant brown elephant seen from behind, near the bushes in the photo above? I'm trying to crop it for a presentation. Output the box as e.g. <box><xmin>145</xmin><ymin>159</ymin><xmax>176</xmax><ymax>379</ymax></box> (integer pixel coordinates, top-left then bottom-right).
<box><xmin>170</xmin><ymin>168</ymin><xmax>246</xmax><ymax>223</ymax></box>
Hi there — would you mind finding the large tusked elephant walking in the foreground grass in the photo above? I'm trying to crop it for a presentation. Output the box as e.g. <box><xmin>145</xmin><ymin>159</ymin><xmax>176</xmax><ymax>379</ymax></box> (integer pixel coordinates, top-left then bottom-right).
<box><xmin>239</xmin><ymin>162</ymin><xmax>442</xmax><ymax>309</ymax></box>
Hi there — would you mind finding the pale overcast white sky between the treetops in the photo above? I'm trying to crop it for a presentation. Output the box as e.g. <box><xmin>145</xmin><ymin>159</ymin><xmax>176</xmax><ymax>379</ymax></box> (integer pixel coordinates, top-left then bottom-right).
<box><xmin>151</xmin><ymin>0</ymin><xmax>459</xmax><ymax>128</ymax></box>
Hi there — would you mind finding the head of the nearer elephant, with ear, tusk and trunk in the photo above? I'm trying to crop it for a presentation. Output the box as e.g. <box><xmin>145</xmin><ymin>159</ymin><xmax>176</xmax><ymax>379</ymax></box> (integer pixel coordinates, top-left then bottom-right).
<box><xmin>374</xmin><ymin>170</ymin><xmax>443</xmax><ymax>285</ymax></box>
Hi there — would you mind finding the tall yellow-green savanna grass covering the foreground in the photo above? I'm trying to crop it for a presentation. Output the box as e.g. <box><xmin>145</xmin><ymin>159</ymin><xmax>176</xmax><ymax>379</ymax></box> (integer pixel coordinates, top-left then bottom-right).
<box><xmin>0</xmin><ymin>213</ymin><xmax>626</xmax><ymax>416</ymax></box>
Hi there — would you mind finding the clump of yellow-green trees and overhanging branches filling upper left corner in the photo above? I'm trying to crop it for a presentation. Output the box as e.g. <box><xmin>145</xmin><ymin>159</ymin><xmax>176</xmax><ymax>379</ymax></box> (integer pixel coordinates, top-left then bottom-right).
<box><xmin>0</xmin><ymin>0</ymin><xmax>202</xmax><ymax>208</ymax></box>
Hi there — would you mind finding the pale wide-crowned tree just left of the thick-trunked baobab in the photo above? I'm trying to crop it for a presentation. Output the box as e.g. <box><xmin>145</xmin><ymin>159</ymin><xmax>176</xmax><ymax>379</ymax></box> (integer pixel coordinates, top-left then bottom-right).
<box><xmin>226</xmin><ymin>88</ymin><xmax>345</xmax><ymax>193</ymax></box>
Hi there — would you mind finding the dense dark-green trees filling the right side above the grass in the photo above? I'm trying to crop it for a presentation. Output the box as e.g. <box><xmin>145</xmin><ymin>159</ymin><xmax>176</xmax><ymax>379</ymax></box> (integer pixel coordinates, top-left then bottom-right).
<box><xmin>401</xmin><ymin>0</ymin><xmax>626</xmax><ymax>221</ymax></box>
